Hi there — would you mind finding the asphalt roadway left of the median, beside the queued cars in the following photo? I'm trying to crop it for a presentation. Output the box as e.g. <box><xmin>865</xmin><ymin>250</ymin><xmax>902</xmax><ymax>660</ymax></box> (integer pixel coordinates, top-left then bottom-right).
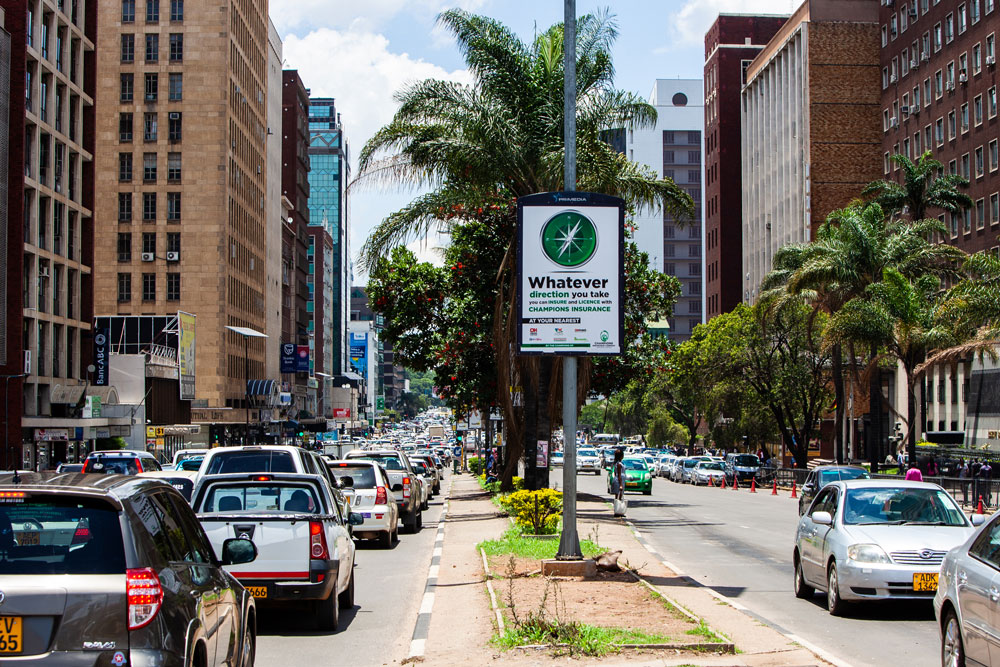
<box><xmin>256</xmin><ymin>477</ymin><xmax>449</xmax><ymax>667</ymax></box>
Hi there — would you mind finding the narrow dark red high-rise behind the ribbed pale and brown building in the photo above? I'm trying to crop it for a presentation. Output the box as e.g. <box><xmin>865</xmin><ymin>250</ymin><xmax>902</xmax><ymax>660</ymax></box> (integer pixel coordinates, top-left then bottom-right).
<box><xmin>705</xmin><ymin>14</ymin><xmax>788</xmax><ymax>319</ymax></box>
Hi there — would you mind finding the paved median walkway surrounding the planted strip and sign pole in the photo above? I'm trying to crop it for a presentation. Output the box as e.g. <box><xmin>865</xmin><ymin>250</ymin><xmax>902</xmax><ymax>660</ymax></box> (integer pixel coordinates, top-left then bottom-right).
<box><xmin>423</xmin><ymin>475</ymin><xmax>829</xmax><ymax>667</ymax></box>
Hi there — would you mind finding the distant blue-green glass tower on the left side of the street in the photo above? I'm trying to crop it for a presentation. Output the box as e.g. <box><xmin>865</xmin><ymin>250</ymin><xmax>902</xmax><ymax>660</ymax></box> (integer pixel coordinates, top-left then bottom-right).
<box><xmin>309</xmin><ymin>102</ymin><xmax>351</xmax><ymax>375</ymax></box>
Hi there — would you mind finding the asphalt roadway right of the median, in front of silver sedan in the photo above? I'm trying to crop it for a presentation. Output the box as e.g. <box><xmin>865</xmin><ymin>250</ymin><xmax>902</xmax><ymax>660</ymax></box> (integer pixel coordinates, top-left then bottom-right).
<box><xmin>568</xmin><ymin>470</ymin><xmax>940</xmax><ymax>667</ymax></box>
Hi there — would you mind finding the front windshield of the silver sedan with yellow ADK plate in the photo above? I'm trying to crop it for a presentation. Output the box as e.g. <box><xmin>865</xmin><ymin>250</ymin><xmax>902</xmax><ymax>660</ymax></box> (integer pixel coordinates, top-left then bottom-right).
<box><xmin>844</xmin><ymin>487</ymin><xmax>968</xmax><ymax>526</ymax></box>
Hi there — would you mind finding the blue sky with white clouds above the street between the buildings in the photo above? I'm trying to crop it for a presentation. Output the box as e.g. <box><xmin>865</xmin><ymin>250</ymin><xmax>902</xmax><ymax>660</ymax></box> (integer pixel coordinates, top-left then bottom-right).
<box><xmin>270</xmin><ymin>0</ymin><xmax>797</xmax><ymax>276</ymax></box>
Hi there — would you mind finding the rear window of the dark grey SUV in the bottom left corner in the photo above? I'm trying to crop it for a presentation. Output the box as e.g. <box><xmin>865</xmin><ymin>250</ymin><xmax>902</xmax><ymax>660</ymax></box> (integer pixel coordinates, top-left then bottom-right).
<box><xmin>0</xmin><ymin>494</ymin><xmax>125</xmax><ymax>575</ymax></box>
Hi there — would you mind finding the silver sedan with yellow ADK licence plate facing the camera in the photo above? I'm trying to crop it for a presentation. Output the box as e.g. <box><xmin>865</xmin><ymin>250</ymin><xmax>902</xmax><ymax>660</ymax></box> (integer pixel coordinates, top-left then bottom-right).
<box><xmin>792</xmin><ymin>479</ymin><xmax>981</xmax><ymax>615</ymax></box>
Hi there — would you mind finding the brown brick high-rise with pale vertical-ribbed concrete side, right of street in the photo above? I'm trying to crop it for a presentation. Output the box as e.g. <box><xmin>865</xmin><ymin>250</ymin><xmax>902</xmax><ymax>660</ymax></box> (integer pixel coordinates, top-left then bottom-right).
<box><xmin>741</xmin><ymin>0</ymin><xmax>882</xmax><ymax>302</ymax></box>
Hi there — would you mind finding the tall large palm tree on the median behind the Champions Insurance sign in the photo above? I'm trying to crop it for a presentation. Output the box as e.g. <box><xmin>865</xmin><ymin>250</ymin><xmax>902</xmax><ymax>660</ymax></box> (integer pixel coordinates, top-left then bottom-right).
<box><xmin>356</xmin><ymin>10</ymin><xmax>694</xmax><ymax>485</ymax></box>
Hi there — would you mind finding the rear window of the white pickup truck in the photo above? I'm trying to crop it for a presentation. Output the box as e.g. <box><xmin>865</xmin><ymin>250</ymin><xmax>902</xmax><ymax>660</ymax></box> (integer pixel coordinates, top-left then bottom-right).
<box><xmin>198</xmin><ymin>482</ymin><xmax>322</xmax><ymax>514</ymax></box>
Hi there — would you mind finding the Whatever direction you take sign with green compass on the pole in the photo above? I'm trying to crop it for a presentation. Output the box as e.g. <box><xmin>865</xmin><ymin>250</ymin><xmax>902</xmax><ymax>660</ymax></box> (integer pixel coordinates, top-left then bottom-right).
<box><xmin>517</xmin><ymin>192</ymin><xmax>625</xmax><ymax>356</ymax></box>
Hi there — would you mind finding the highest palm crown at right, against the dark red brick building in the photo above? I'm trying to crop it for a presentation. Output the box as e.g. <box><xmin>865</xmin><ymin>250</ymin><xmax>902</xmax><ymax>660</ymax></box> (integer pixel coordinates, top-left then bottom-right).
<box><xmin>862</xmin><ymin>151</ymin><xmax>972</xmax><ymax>220</ymax></box>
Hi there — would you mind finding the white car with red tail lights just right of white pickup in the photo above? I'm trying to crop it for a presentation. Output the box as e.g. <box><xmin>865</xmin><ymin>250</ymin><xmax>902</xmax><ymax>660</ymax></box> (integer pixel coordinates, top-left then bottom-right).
<box><xmin>326</xmin><ymin>459</ymin><xmax>399</xmax><ymax>549</ymax></box>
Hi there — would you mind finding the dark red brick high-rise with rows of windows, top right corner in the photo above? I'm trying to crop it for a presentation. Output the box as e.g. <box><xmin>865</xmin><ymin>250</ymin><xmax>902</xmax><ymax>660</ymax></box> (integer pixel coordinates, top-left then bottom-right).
<box><xmin>878</xmin><ymin>0</ymin><xmax>1000</xmax><ymax>253</ymax></box>
